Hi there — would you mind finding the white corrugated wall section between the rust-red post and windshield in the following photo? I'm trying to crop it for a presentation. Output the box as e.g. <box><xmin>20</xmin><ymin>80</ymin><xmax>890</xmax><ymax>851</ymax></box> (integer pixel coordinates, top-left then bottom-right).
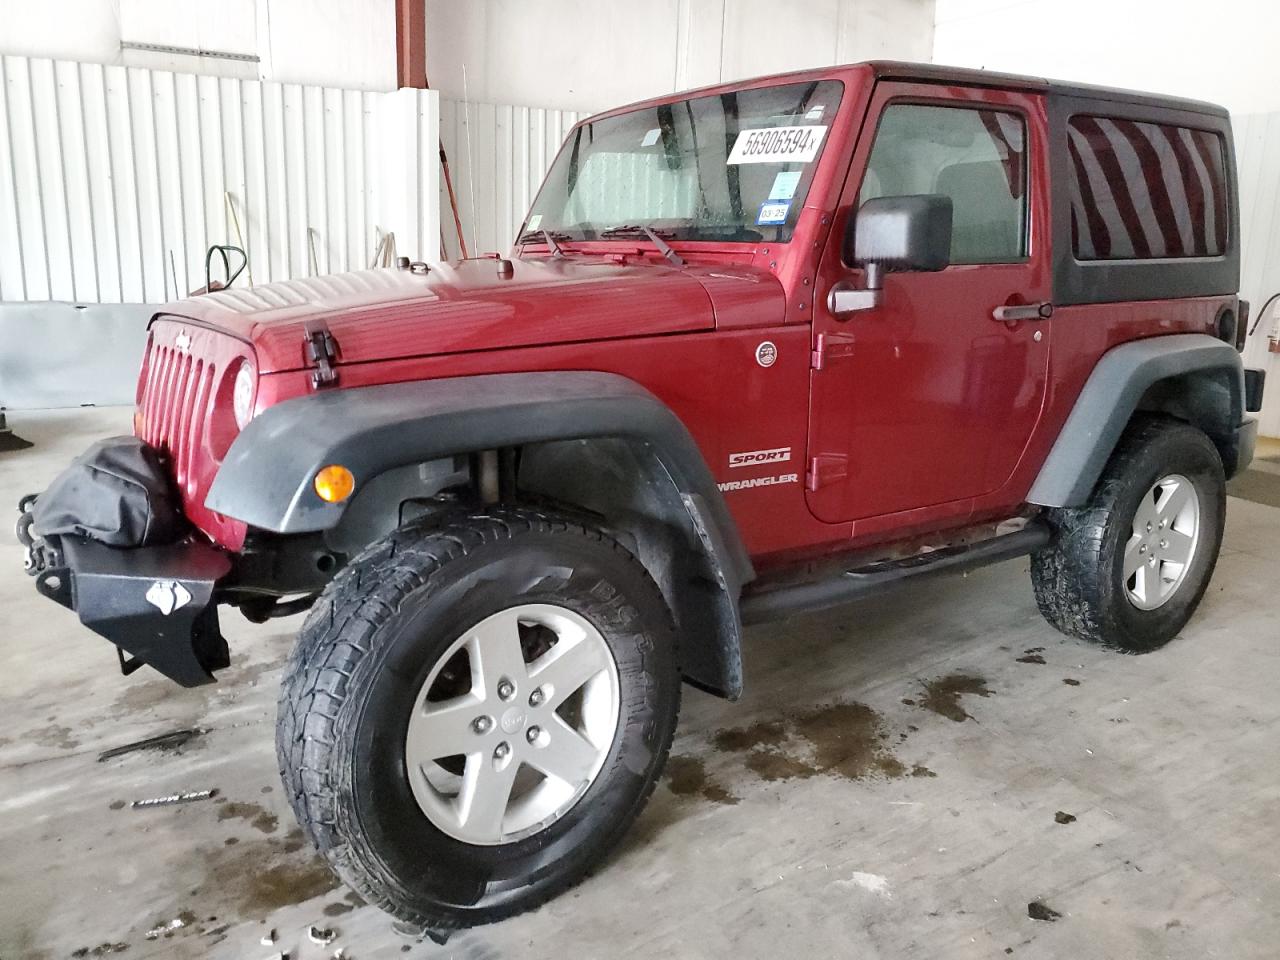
<box><xmin>440</xmin><ymin>100</ymin><xmax>581</xmax><ymax>259</ymax></box>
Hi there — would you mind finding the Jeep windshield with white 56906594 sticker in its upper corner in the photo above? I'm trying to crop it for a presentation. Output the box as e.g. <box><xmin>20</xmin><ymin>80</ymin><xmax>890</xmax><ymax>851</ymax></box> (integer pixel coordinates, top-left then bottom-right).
<box><xmin>521</xmin><ymin>81</ymin><xmax>844</xmax><ymax>242</ymax></box>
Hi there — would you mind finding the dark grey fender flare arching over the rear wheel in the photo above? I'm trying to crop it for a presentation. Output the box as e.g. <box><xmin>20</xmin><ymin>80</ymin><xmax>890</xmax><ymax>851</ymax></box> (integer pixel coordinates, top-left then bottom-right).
<box><xmin>1027</xmin><ymin>333</ymin><xmax>1244</xmax><ymax>507</ymax></box>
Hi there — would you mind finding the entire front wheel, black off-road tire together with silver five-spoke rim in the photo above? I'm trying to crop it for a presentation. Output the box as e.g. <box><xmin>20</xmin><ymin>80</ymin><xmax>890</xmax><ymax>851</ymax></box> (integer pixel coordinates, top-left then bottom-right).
<box><xmin>276</xmin><ymin>509</ymin><xmax>680</xmax><ymax>929</ymax></box>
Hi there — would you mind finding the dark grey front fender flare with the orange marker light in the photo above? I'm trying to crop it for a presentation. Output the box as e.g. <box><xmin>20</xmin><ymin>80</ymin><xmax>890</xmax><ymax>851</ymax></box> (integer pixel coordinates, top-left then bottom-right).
<box><xmin>205</xmin><ymin>371</ymin><xmax>755</xmax><ymax>699</ymax></box>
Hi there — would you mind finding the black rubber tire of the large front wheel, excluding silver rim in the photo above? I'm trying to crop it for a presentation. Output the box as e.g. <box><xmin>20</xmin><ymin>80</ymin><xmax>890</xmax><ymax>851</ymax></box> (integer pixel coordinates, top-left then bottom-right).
<box><xmin>276</xmin><ymin>508</ymin><xmax>680</xmax><ymax>931</ymax></box>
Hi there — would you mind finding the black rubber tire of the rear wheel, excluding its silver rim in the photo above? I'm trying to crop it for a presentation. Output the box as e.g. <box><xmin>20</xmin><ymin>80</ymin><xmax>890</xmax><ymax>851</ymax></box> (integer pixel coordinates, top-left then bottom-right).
<box><xmin>1032</xmin><ymin>416</ymin><xmax>1226</xmax><ymax>653</ymax></box>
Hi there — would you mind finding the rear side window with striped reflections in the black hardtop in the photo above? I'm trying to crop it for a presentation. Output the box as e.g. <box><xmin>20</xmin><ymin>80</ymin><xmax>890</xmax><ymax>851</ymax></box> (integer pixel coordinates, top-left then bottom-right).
<box><xmin>1066</xmin><ymin>115</ymin><xmax>1228</xmax><ymax>260</ymax></box>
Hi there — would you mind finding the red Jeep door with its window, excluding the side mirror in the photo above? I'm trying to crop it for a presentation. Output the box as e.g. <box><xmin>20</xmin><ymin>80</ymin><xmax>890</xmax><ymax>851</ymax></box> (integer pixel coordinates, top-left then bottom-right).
<box><xmin>805</xmin><ymin>83</ymin><xmax>1052</xmax><ymax>534</ymax></box>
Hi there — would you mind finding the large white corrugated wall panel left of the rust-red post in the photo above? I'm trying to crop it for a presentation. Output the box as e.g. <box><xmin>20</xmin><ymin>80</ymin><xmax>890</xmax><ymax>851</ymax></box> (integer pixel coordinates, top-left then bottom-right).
<box><xmin>0</xmin><ymin>56</ymin><xmax>439</xmax><ymax>303</ymax></box>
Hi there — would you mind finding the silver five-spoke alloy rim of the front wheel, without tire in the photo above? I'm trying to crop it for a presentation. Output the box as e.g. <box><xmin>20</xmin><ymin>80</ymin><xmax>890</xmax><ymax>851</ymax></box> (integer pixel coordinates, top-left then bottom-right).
<box><xmin>404</xmin><ymin>603</ymin><xmax>621</xmax><ymax>845</ymax></box>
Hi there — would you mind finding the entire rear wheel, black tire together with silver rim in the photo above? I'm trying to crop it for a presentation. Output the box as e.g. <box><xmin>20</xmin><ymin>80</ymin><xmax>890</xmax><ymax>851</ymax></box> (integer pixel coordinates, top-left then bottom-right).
<box><xmin>1032</xmin><ymin>419</ymin><xmax>1226</xmax><ymax>653</ymax></box>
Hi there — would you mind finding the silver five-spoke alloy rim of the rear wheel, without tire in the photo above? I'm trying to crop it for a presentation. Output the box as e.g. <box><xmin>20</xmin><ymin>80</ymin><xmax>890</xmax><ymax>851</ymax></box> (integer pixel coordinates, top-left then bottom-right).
<box><xmin>1123</xmin><ymin>474</ymin><xmax>1199</xmax><ymax>611</ymax></box>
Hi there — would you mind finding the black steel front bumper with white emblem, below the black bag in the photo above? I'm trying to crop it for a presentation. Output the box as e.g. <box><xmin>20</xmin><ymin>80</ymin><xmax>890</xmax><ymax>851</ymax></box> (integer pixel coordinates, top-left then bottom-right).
<box><xmin>18</xmin><ymin>498</ymin><xmax>232</xmax><ymax>686</ymax></box>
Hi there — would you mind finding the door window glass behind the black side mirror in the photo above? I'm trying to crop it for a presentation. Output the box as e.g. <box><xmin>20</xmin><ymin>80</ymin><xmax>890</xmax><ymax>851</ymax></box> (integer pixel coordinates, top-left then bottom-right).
<box><xmin>858</xmin><ymin>104</ymin><xmax>1027</xmax><ymax>264</ymax></box>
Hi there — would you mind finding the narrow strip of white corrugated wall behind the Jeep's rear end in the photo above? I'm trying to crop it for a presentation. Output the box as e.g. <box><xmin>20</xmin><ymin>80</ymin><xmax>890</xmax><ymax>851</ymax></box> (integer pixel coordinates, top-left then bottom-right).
<box><xmin>1231</xmin><ymin>113</ymin><xmax>1280</xmax><ymax>436</ymax></box>
